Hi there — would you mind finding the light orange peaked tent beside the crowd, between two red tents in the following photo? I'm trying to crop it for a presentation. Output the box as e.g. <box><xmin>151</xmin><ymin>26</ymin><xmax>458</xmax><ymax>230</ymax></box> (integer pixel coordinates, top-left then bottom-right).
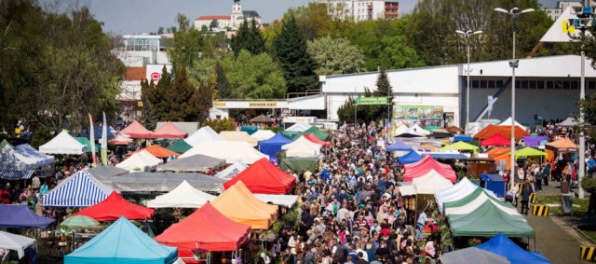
<box><xmin>211</xmin><ymin>181</ymin><xmax>278</xmax><ymax>230</ymax></box>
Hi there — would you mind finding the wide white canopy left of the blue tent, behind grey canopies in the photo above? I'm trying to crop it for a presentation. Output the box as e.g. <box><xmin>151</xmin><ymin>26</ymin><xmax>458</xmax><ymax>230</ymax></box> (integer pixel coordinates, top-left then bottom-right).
<box><xmin>178</xmin><ymin>141</ymin><xmax>269</xmax><ymax>164</ymax></box>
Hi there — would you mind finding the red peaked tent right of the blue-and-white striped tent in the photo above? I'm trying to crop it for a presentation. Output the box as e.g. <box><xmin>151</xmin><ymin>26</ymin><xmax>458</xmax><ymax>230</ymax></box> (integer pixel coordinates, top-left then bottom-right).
<box><xmin>73</xmin><ymin>191</ymin><xmax>154</xmax><ymax>221</ymax></box>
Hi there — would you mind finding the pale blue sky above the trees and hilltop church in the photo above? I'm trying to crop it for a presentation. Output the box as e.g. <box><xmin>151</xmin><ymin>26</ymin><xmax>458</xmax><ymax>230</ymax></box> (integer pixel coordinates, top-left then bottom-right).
<box><xmin>40</xmin><ymin>0</ymin><xmax>557</xmax><ymax>34</ymax></box>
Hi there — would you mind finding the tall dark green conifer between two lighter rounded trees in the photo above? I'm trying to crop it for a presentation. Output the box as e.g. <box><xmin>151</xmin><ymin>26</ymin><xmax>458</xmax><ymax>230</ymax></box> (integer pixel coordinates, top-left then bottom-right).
<box><xmin>272</xmin><ymin>17</ymin><xmax>318</xmax><ymax>93</ymax></box>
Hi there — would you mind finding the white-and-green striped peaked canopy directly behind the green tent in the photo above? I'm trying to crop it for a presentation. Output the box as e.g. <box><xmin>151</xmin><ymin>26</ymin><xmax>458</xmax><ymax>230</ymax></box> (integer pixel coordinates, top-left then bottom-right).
<box><xmin>443</xmin><ymin>188</ymin><xmax>520</xmax><ymax>216</ymax></box>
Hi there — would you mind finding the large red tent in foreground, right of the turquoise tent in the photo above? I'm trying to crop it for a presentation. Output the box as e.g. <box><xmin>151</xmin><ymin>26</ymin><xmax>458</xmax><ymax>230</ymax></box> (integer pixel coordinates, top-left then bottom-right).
<box><xmin>155</xmin><ymin>202</ymin><xmax>251</xmax><ymax>257</ymax></box>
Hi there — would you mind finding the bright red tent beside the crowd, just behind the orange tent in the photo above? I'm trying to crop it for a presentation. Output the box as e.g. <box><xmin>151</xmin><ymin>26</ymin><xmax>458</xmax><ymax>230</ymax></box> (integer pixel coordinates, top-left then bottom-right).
<box><xmin>224</xmin><ymin>158</ymin><xmax>296</xmax><ymax>194</ymax></box>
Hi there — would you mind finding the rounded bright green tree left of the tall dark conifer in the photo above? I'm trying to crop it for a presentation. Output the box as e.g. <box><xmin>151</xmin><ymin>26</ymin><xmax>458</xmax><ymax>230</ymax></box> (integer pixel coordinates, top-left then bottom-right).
<box><xmin>227</xmin><ymin>50</ymin><xmax>286</xmax><ymax>99</ymax></box>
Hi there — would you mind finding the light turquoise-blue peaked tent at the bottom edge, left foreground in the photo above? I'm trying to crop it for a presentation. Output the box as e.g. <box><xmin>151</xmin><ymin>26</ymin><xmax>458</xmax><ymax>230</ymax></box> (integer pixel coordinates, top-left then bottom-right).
<box><xmin>64</xmin><ymin>217</ymin><xmax>178</xmax><ymax>264</ymax></box>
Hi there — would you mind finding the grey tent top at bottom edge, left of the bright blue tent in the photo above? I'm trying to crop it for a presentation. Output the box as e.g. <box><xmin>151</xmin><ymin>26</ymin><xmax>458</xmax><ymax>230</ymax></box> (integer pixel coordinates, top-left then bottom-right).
<box><xmin>439</xmin><ymin>247</ymin><xmax>510</xmax><ymax>264</ymax></box>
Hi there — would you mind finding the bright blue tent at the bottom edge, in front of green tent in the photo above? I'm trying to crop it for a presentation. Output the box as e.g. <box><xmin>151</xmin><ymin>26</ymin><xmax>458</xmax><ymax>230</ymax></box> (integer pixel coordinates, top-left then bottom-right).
<box><xmin>476</xmin><ymin>233</ymin><xmax>551</xmax><ymax>264</ymax></box>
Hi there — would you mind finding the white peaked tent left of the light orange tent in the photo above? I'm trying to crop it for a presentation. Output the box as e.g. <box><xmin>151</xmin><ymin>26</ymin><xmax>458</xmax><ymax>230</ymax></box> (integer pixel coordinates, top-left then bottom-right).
<box><xmin>147</xmin><ymin>180</ymin><xmax>215</xmax><ymax>208</ymax></box>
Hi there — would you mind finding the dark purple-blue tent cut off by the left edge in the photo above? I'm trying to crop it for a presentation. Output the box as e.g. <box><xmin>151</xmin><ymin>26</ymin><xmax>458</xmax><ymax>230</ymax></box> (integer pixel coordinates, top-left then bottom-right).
<box><xmin>0</xmin><ymin>204</ymin><xmax>54</xmax><ymax>228</ymax></box>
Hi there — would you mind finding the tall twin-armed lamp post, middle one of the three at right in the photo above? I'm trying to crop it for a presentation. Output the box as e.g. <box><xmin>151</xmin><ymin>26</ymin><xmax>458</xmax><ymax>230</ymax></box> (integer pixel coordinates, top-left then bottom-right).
<box><xmin>495</xmin><ymin>7</ymin><xmax>534</xmax><ymax>189</ymax></box>
